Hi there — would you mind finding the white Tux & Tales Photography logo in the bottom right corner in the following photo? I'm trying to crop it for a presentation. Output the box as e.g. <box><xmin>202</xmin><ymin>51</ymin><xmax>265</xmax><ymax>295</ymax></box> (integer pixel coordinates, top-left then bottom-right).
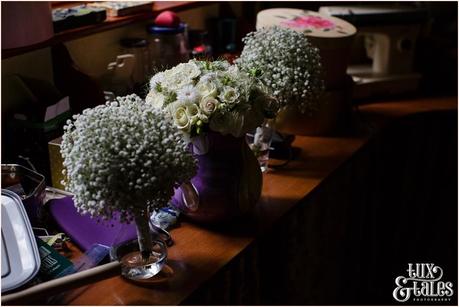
<box><xmin>392</xmin><ymin>263</ymin><xmax>454</xmax><ymax>303</ymax></box>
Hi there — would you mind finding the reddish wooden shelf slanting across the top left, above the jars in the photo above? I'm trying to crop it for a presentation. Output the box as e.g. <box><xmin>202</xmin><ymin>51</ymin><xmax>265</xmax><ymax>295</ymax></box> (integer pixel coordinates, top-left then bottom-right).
<box><xmin>2</xmin><ymin>1</ymin><xmax>216</xmax><ymax>59</ymax></box>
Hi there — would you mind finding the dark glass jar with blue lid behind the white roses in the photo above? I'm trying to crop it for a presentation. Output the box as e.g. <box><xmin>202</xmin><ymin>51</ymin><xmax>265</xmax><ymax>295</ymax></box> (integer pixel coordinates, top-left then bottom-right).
<box><xmin>147</xmin><ymin>23</ymin><xmax>190</xmax><ymax>73</ymax></box>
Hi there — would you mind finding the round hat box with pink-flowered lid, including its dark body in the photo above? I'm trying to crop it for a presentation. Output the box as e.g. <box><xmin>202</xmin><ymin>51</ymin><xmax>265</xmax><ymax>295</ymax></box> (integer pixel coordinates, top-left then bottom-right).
<box><xmin>256</xmin><ymin>8</ymin><xmax>357</xmax><ymax>135</ymax></box>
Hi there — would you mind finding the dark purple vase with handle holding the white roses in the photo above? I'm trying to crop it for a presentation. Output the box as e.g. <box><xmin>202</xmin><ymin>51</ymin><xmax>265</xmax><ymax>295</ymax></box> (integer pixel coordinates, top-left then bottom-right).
<box><xmin>172</xmin><ymin>132</ymin><xmax>262</xmax><ymax>223</ymax></box>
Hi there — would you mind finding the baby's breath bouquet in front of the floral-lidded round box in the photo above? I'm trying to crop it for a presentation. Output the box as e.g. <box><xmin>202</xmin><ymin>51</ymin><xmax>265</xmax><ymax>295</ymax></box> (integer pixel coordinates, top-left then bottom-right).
<box><xmin>236</xmin><ymin>26</ymin><xmax>324</xmax><ymax>113</ymax></box>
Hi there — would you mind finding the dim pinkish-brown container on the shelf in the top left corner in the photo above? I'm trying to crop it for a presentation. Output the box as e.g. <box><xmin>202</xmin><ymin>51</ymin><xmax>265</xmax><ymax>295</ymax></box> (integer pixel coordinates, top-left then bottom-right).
<box><xmin>1</xmin><ymin>1</ymin><xmax>54</xmax><ymax>49</ymax></box>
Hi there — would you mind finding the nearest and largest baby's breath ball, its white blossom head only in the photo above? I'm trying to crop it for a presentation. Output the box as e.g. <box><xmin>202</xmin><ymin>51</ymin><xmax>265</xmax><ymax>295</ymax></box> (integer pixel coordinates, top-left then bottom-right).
<box><xmin>61</xmin><ymin>95</ymin><xmax>196</xmax><ymax>222</ymax></box>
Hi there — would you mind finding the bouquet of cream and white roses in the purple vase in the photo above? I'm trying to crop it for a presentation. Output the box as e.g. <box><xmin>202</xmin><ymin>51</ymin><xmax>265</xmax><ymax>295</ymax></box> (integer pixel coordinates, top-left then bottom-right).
<box><xmin>145</xmin><ymin>60</ymin><xmax>278</xmax><ymax>141</ymax></box>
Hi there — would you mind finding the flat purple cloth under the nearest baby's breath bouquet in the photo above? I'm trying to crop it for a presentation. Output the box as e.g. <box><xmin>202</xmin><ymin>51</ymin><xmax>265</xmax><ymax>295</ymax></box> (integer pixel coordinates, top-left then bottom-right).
<box><xmin>48</xmin><ymin>197</ymin><xmax>137</xmax><ymax>251</ymax></box>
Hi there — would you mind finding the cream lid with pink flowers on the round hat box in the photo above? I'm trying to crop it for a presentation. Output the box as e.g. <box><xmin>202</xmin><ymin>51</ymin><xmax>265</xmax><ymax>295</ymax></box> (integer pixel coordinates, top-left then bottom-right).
<box><xmin>257</xmin><ymin>8</ymin><xmax>357</xmax><ymax>45</ymax></box>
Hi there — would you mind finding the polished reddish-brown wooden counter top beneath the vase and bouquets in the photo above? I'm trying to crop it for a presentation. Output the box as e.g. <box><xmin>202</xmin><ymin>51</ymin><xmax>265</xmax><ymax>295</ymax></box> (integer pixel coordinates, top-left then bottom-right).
<box><xmin>6</xmin><ymin>97</ymin><xmax>457</xmax><ymax>305</ymax></box>
